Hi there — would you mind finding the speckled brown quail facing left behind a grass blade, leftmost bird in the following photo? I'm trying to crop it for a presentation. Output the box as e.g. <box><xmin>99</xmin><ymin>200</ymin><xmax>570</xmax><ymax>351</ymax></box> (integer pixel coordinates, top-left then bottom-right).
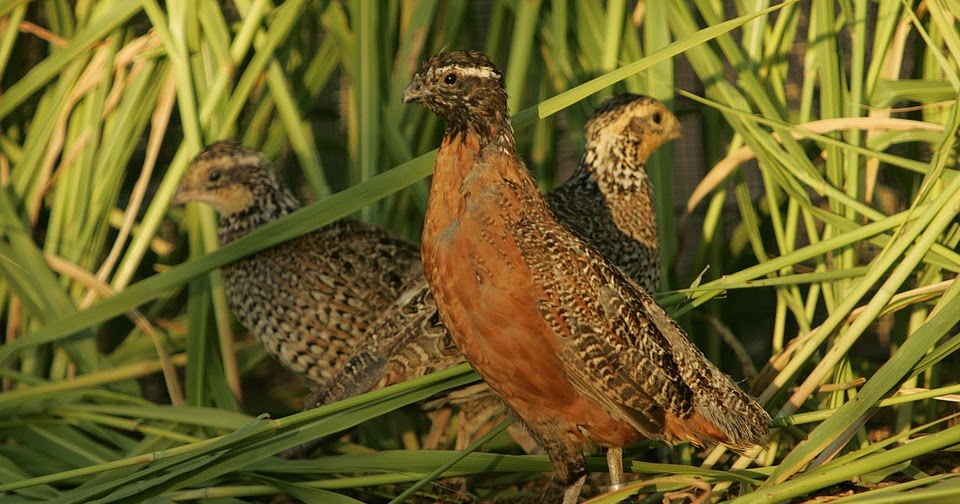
<box><xmin>174</xmin><ymin>140</ymin><xmax>422</xmax><ymax>383</ymax></box>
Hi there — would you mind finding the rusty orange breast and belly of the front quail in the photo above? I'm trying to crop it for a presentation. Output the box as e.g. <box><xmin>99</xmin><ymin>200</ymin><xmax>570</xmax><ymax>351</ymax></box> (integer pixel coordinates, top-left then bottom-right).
<box><xmin>422</xmin><ymin>133</ymin><xmax>641</xmax><ymax>446</ymax></box>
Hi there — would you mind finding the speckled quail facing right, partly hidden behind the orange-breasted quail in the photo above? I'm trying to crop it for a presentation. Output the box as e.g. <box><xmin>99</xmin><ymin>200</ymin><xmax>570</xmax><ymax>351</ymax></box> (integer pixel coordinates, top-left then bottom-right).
<box><xmin>308</xmin><ymin>93</ymin><xmax>680</xmax><ymax>424</ymax></box>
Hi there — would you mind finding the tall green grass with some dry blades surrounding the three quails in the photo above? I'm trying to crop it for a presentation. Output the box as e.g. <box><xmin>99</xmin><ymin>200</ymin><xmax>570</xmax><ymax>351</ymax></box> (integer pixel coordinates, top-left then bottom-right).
<box><xmin>0</xmin><ymin>0</ymin><xmax>960</xmax><ymax>502</ymax></box>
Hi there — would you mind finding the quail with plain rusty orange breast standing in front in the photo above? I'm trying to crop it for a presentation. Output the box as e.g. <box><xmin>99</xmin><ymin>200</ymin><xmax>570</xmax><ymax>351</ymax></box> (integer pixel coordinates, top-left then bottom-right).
<box><xmin>403</xmin><ymin>51</ymin><xmax>769</xmax><ymax>504</ymax></box>
